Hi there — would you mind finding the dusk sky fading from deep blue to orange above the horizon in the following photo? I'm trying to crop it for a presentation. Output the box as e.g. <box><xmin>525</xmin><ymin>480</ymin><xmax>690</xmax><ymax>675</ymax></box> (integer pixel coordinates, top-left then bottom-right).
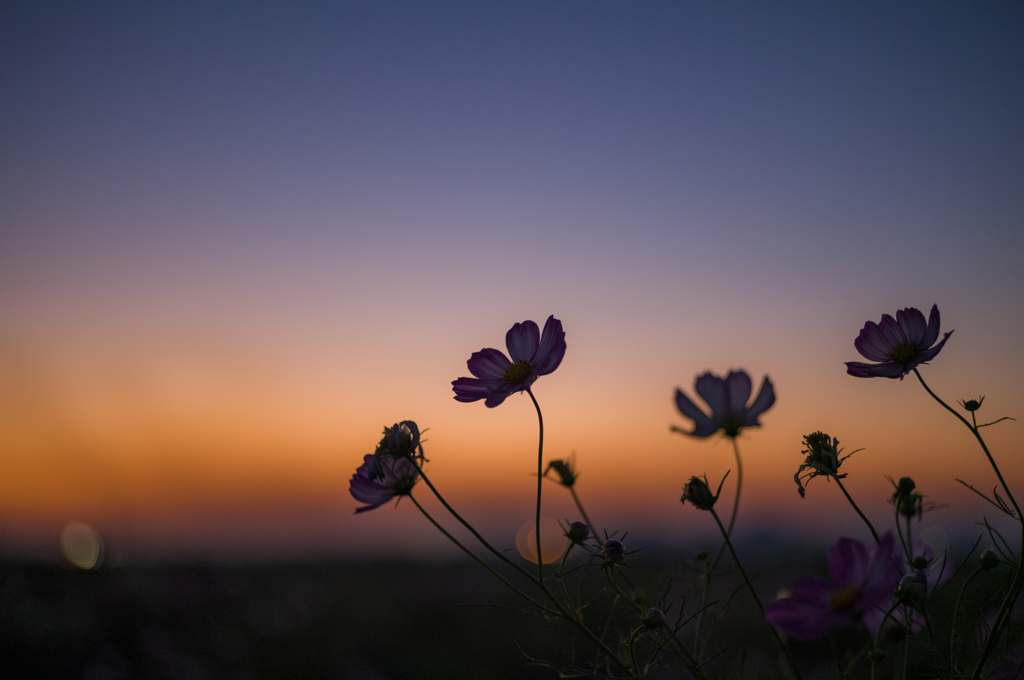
<box><xmin>0</xmin><ymin>1</ymin><xmax>1024</xmax><ymax>561</ymax></box>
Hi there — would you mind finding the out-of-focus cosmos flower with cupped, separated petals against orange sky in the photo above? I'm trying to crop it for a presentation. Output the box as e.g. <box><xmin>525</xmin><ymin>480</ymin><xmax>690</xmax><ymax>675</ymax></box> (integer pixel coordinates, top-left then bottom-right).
<box><xmin>672</xmin><ymin>371</ymin><xmax>775</xmax><ymax>437</ymax></box>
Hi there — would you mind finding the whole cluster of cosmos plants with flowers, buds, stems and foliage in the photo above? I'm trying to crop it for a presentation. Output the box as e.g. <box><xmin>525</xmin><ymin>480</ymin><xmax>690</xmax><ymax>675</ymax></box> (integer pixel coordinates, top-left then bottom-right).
<box><xmin>350</xmin><ymin>306</ymin><xmax>1024</xmax><ymax>680</ymax></box>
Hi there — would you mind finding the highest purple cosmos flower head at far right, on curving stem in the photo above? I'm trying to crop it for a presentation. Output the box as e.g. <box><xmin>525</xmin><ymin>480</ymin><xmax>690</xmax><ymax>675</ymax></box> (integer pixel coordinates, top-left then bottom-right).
<box><xmin>846</xmin><ymin>304</ymin><xmax>952</xmax><ymax>380</ymax></box>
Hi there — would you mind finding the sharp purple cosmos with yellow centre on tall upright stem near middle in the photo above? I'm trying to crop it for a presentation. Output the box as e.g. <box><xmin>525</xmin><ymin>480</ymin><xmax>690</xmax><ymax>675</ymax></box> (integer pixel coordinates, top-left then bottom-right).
<box><xmin>452</xmin><ymin>316</ymin><xmax>565</xmax><ymax>409</ymax></box>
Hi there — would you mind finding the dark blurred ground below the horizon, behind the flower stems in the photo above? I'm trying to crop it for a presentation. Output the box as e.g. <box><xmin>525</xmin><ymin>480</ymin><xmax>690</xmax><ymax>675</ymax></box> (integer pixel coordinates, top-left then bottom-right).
<box><xmin>0</xmin><ymin>560</ymin><xmax>1015</xmax><ymax>680</ymax></box>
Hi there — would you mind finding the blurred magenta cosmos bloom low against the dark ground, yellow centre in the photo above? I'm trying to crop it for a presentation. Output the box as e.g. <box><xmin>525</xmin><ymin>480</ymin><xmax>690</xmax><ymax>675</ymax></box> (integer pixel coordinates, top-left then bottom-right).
<box><xmin>765</xmin><ymin>533</ymin><xmax>902</xmax><ymax>642</ymax></box>
